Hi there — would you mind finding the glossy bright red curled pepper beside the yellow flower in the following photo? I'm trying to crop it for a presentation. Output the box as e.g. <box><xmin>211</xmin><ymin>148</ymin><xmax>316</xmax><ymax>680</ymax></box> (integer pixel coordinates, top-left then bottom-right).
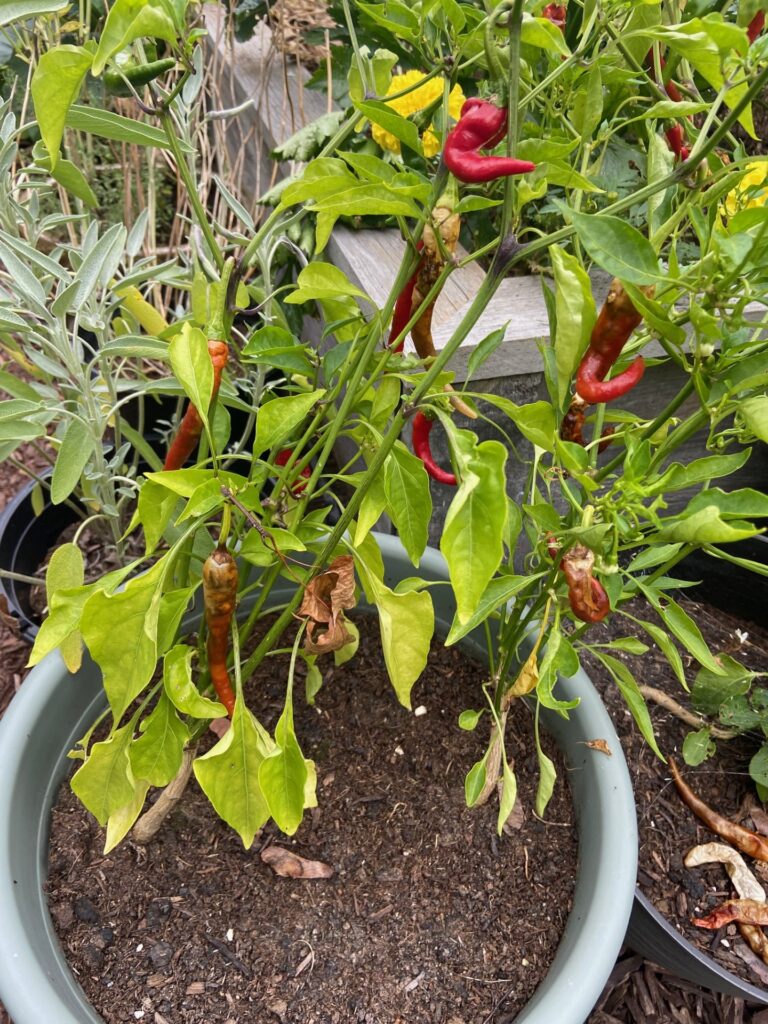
<box><xmin>442</xmin><ymin>96</ymin><xmax>536</xmax><ymax>184</ymax></box>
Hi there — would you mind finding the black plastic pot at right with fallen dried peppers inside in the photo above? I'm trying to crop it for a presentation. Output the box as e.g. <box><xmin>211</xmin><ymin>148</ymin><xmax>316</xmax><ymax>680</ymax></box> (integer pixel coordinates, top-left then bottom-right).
<box><xmin>627</xmin><ymin>536</ymin><xmax>768</xmax><ymax>1006</ymax></box>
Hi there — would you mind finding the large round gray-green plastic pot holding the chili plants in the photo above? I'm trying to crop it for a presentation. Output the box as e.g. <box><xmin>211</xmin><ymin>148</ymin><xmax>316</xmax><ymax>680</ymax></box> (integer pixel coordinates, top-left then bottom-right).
<box><xmin>0</xmin><ymin>536</ymin><xmax>637</xmax><ymax>1024</ymax></box>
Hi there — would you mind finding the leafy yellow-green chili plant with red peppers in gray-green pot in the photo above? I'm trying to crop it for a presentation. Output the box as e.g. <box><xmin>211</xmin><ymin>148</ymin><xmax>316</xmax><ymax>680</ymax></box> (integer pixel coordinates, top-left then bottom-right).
<box><xmin>10</xmin><ymin>0</ymin><xmax>768</xmax><ymax>849</ymax></box>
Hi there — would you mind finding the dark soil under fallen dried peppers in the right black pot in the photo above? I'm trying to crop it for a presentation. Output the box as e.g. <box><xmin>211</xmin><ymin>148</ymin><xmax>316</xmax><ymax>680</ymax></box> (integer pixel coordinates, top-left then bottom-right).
<box><xmin>588</xmin><ymin>602</ymin><xmax>768</xmax><ymax>1003</ymax></box>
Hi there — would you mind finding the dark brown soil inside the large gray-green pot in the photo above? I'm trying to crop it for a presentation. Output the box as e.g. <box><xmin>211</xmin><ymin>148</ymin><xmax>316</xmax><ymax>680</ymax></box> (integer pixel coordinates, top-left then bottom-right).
<box><xmin>49</xmin><ymin>618</ymin><xmax>577</xmax><ymax>1024</ymax></box>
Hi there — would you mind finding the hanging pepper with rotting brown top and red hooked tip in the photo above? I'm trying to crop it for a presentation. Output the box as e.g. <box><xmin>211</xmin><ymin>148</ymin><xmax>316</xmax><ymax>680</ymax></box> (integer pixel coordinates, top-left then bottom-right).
<box><xmin>575</xmin><ymin>278</ymin><xmax>653</xmax><ymax>403</ymax></box>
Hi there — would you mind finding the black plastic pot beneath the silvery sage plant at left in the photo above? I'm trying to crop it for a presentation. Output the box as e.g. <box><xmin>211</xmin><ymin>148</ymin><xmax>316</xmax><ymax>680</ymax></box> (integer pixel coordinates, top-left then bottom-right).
<box><xmin>0</xmin><ymin>483</ymin><xmax>78</xmax><ymax>640</ymax></box>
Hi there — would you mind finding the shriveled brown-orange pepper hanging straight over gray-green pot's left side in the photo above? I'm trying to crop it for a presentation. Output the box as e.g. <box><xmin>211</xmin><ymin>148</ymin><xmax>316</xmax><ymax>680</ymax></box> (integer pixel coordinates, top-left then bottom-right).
<box><xmin>203</xmin><ymin>546</ymin><xmax>238</xmax><ymax>718</ymax></box>
